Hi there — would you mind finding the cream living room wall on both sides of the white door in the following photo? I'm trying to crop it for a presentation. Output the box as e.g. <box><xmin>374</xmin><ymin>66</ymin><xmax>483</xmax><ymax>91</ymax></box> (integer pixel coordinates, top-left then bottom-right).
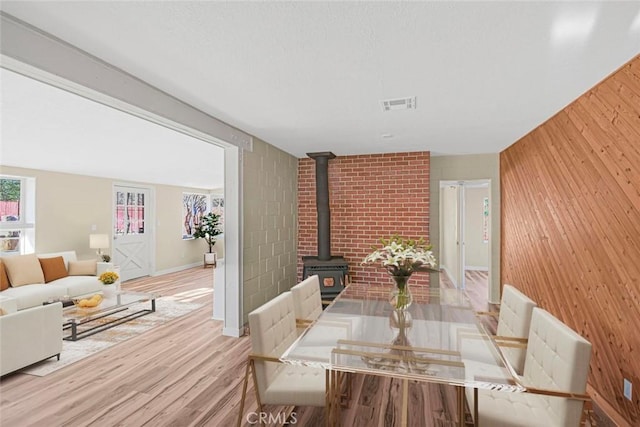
<box><xmin>0</xmin><ymin>166</ymin><xmax>207</xmax><ymax>271</ymax></box>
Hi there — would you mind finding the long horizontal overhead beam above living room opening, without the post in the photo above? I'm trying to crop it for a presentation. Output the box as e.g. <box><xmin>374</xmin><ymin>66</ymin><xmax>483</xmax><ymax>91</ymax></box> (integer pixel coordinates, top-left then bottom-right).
<box><xmin>0</xmin><ymin>12</ymin><xmax>253</xmax><ymax>151</ymax></box>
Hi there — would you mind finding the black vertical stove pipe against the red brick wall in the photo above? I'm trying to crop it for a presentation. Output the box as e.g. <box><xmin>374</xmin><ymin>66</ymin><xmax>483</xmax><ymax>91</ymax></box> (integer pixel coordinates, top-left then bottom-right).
<box><xmin>307</xmin><ymin>151</ymin><xmax>336</xmax><ymax>261</ymax></box>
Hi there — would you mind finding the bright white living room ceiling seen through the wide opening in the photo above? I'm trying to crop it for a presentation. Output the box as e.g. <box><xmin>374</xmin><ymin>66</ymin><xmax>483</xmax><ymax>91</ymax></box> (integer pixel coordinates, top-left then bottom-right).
<box><xmin>0</xmin><ymin>69</ymin><xmax>224</xmax><ymax>189</ymax></box>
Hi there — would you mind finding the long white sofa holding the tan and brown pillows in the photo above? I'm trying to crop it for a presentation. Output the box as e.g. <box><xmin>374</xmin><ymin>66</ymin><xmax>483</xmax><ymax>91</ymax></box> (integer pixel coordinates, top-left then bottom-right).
<box><xmin>0</xmin><ymin>251</ymin><xmax>103</xmax><ymax>310</ymax></box>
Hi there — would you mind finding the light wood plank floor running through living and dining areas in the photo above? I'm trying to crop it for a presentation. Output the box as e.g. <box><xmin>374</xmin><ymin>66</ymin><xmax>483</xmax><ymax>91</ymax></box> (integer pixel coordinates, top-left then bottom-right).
<box><xmin>0</xmin><ymin>268</ymin><xmax>608</xmax><ymax>427</ymax></box>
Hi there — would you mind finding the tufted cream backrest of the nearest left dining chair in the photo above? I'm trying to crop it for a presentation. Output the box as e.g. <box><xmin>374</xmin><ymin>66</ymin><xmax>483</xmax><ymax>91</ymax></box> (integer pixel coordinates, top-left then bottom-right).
<box><xmin>249</xmin><ymin>292</ymin><xmax>298</xmax><ymax>396</ymax></box>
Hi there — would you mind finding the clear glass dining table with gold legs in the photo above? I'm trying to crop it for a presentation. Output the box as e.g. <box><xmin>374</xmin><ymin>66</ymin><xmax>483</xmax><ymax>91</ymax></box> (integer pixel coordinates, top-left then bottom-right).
<box><xmin>281</xmin><ymin>284</ymin><xmax>525</xmax><ymax>426</ymax></box>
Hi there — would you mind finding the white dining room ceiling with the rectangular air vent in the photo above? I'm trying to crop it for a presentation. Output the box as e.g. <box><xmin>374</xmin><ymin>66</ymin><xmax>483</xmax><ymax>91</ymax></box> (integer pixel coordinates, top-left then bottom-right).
<box><xmin>0</xmin><ymin>1</ymin><xmax>640</xmax><ymax>176</ymax></box>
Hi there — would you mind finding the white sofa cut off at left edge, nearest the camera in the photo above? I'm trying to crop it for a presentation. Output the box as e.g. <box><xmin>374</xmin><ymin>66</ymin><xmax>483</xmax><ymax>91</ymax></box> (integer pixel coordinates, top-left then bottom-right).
<box><xmin>0</xmin><ymin>296</ymin><xmax>62</xmax><ymax>376</ymax></box>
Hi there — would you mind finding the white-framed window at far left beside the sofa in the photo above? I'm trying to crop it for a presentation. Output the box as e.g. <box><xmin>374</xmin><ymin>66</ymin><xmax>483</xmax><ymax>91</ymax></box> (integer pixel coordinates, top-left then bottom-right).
<box><xmin>0</xmin><ymin>175</ymin><xmax>35</xmax><ymax>256</ymax></box>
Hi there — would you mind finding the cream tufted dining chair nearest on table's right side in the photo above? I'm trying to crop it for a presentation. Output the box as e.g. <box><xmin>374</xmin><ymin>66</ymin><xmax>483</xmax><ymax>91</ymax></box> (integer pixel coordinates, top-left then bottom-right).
<box><xmin>467</xmin><ymin>308</ymin><xmax>591</xmax><ymax>427</ymax></box>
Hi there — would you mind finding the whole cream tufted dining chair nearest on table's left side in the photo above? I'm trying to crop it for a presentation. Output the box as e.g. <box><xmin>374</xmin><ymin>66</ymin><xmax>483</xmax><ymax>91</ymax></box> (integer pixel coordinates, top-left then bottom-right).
<box><xmin>238</xmin><ymin>292</ymin><xmax>326</xmax><ymax>426</ymax></box>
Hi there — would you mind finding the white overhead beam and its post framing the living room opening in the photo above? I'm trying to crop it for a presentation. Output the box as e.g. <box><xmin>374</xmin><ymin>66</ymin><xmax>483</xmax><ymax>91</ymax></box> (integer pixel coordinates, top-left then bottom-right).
<box><xmin>0</xmin><ymin>11</ymin><xmax>246</xmax><ymax>336</ymax></box>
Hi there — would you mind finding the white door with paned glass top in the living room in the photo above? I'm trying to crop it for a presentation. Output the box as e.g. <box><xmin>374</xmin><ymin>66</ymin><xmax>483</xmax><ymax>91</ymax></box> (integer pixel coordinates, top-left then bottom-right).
<box><xmin>113</xmin><ymin>185</ymin><xmax>151</xmax><ymax>281</ymax></box>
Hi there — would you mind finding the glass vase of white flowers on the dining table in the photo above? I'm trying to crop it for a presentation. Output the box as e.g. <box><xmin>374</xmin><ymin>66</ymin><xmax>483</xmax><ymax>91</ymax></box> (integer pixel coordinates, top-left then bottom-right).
<box><xmin>362</xmin><ymin>235</ymin><xmax>437</xmax><ymax>310</ymax></box>
